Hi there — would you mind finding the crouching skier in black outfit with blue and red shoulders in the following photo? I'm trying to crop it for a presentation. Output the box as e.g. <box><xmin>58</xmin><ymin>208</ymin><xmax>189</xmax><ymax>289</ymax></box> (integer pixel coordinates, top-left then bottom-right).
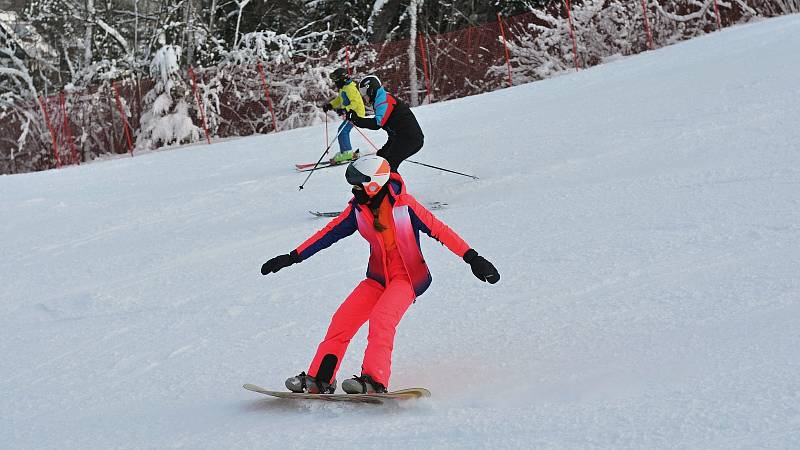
<box><xmin>347</xmin><ymin>75</ymin><xmax>425</xmax><ymax>172</ymax></box>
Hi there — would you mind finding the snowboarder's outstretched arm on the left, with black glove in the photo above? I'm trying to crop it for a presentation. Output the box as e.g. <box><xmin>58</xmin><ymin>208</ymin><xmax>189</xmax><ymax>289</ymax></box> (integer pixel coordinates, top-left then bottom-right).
<box><xmin>261</xmin><ymin>204</ymin><xmax>358</xmax><ymax>275</ymax></box>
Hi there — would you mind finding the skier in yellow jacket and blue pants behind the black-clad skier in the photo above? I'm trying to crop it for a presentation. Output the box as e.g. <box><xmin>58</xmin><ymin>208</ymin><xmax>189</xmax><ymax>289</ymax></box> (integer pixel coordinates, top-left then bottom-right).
<box><xmin>322</xmin><ymin>67</ymin><xmax>366</xmax><ymax>164</ymax></box>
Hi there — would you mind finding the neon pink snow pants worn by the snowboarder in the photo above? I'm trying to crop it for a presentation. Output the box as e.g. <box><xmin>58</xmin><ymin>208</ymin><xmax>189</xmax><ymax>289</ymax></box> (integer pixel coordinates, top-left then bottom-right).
<box><xmin>308</xmin><ymin>250</ymin><xmax>415</xmax><ymax>387</ymax></box>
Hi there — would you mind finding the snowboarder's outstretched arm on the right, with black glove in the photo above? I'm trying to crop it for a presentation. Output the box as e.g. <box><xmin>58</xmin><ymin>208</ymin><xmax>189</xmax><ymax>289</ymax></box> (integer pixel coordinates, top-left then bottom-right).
<box><xmin>405</xmin><ymin>195</ymin><xmax>500</xmax><ymax>284</ymax></box>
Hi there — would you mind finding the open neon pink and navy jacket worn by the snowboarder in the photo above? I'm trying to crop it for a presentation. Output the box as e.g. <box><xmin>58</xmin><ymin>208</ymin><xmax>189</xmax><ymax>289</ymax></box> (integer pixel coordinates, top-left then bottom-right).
<box><xmin>296</xmin><ymin>173</ymin><xmax>470</xmax><ymax>296</ymax></box>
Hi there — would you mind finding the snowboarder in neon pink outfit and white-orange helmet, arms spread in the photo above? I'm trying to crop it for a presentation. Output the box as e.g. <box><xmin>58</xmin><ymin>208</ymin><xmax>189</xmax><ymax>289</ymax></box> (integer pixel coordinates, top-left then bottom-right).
<box><xmin>261</xmin><ymin>156</ymin><xmax>500</xmax><ymax>394</ymax></box>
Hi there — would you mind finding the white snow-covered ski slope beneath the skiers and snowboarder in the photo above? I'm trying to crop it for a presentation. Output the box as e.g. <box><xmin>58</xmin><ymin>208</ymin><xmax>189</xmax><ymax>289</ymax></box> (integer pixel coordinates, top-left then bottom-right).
<box><xmin>0</xmin><ymin>15</ymin><xmax>800</xmax><ymax>449</ymax></box>
